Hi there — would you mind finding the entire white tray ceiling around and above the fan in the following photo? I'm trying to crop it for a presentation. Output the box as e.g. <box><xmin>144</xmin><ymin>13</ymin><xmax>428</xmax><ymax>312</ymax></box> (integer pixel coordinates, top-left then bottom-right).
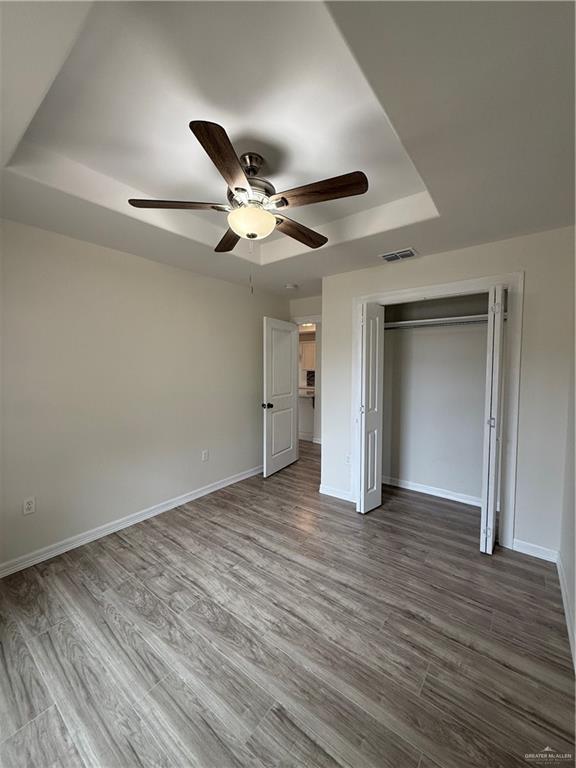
<box><xmin>3</xmin><ymin>2</ymin><xmax>574</xmax><ymax>295</ymax></box>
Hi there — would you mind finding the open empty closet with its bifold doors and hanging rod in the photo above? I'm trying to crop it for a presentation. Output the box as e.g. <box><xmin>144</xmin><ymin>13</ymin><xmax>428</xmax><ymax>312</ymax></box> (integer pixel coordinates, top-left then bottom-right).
<box><xmin>357</xmin><ymin>285</ymin><xmax>508</xmax><ymax>554</ymax></box>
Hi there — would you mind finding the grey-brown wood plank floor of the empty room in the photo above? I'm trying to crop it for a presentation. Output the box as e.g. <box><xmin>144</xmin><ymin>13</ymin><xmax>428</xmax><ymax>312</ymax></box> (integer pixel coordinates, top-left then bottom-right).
<box><xmin>0</xmin><ymin>443</ymin><xmax>574</xmax><ymax>768</ymax></box>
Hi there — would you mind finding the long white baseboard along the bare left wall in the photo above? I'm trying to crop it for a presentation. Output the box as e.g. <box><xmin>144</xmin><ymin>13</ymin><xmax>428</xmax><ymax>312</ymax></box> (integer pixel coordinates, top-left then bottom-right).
<box><xmin>0</xmin><ymin>466</ymin><xmax>262</xmax><ymax>579</ymax></box>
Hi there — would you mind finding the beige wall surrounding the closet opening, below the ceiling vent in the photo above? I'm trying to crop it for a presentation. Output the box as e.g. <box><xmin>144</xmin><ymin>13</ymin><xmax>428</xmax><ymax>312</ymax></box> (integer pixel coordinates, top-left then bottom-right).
<box><xmin>322</xmin><ymin>228</ymin><xmax>574</xmax><ymax>550</ymax></box>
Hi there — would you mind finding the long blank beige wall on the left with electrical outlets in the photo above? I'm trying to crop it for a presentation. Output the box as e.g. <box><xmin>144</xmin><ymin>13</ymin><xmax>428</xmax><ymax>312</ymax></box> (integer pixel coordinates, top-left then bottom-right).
<box><xmin>0</xmin><ymin>222</ymin><xmax>289</xmax><ymax>561</ymax></box>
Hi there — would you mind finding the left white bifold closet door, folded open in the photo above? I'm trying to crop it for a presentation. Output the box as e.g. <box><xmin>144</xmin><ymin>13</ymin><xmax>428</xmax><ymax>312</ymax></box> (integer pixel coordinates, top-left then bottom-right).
<box><xmin>356</xmin><ymin>304</ymin><xmax>384</xmax><ymax>514</ymax></box>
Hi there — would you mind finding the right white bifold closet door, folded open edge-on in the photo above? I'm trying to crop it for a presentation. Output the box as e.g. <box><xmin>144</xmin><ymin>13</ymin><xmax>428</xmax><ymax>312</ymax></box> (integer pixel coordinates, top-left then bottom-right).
<box><xmin>480</xmin><ymin>286</ymin><xmax>504</xmax><ymax>555</ymax></box>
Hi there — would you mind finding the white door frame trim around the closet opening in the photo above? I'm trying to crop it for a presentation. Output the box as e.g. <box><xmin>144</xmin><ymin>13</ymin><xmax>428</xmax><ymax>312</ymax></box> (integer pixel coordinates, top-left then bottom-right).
<box><xmin>350</xmin><ymin>272</ymin><xmax>524</xmax><ymax>549</ymax></box>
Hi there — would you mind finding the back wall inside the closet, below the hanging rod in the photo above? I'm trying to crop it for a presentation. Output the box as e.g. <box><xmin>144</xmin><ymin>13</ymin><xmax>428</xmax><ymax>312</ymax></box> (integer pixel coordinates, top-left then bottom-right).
<box><xmin>382</xmin><ymin>324</ymin><xmax>487</xmax><ymax>504</ymax></box>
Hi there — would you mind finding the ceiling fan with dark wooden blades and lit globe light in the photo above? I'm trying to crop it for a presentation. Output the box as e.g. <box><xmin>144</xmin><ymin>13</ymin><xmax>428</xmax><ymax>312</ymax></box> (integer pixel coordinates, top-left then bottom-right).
<box><xmin>128</xmin><ymin>120</ymin><xmax>368</xmax><ymax>253</ymax></box>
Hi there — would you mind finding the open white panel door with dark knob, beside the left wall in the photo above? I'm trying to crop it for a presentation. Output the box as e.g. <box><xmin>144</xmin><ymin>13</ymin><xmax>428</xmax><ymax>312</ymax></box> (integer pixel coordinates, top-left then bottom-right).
<box><xmin>262</xmin><ymin>317</ymin><xmax>298</xmax><ymax>477</ymax></box>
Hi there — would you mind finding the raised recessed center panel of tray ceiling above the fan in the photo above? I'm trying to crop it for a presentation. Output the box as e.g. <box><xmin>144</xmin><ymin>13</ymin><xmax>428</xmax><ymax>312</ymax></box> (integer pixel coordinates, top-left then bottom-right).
<box><xmin>26</xmin><ymin>2</ymin><xmax>424</xmax><ymax>231</ymax></box>
